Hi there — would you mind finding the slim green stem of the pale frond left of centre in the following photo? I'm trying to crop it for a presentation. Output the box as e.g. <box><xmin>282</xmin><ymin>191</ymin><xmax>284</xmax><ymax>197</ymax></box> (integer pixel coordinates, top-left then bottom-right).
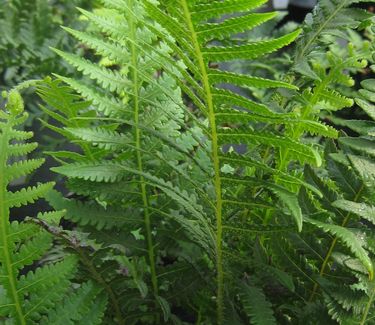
<box><xmin>129</xmin><ymin>0</ymin><xmax>159</xmax><ymax>297</ymax></box>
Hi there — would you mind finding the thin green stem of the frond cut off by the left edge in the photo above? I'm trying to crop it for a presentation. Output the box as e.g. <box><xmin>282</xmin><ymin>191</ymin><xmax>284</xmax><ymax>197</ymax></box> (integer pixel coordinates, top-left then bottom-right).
<box><xmin>0</xmin><ymin>117</ymin><xmax>26</xmax><ymax>325</ymax></box>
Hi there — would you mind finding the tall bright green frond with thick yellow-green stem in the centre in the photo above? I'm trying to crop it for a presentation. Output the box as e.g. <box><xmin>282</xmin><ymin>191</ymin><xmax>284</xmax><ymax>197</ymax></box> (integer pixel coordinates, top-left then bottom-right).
<box><xmin>142</xmin><ymin>1</ymin><xmax>338</xmax><ymax>323</ymax></box>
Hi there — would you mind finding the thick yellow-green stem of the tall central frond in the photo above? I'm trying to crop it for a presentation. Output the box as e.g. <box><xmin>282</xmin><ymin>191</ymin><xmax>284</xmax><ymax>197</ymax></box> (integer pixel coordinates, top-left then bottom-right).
<box><xmin>180</xmin><ymin>0</ymin><xmax>224</xmax><ymax>324</ymax></box>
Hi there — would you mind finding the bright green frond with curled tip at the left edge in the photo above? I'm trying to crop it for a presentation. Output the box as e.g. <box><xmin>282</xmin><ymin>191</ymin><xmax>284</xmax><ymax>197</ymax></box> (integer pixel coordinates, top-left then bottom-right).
<box><xmin>0</xmin><ymin>90</ymin><xmax>105</xmax><ymax>325</ymax></box>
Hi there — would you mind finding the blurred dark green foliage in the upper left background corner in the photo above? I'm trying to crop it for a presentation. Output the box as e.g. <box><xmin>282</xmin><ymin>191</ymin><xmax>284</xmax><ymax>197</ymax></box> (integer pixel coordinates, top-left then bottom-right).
<box><xmin>0</xmin><ymin>0</ymin><xmax>95</xmax><ymax>125</ymax></box>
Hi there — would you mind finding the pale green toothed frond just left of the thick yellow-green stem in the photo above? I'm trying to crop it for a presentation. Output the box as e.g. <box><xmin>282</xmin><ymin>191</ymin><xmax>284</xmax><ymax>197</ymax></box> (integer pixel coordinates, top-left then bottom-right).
<box><xmin>38</xmin><ymin>1</ymin><xmax>216</xmax><ymax>323</ymax></box>
